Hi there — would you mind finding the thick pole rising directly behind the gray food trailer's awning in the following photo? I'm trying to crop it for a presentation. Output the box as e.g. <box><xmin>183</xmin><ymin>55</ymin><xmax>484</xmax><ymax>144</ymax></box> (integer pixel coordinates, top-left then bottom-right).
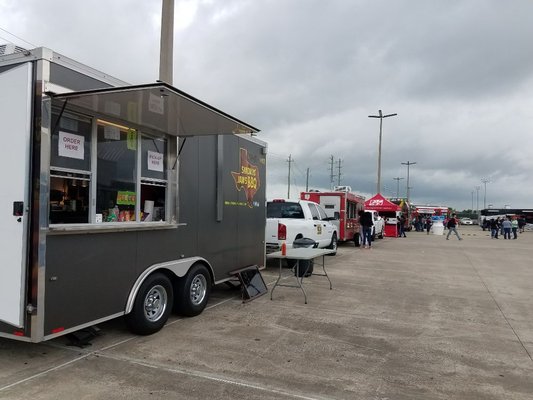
<box><xmin>159</xmin><ymin>0</ymin><xmax>174</xmax><ymax>85</ymax></box>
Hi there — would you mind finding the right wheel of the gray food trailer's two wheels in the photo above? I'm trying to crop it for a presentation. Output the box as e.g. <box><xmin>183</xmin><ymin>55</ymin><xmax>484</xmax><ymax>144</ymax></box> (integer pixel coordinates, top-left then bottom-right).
<box><xmin>174</xmin><ymin>264</ymin><xmax>211</xmax><ymax>317</ymax></box>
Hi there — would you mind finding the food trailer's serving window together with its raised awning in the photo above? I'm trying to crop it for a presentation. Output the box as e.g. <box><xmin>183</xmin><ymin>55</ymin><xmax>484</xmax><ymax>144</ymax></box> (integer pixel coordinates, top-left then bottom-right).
<box><xmin>49</xmin><ymin>83</ymin><xmax>258</xmax><ymax>227</ymax></box>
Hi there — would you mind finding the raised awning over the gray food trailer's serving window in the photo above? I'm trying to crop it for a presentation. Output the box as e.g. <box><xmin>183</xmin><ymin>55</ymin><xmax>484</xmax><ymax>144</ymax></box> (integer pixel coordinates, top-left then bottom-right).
<box><xmin>48</xmin><ymin>83</ymin><xmax>259</xmax><ymax>136</ymax></box>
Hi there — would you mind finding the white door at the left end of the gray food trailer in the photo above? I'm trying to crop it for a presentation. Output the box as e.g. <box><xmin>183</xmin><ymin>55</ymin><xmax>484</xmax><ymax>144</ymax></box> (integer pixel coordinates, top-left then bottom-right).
<box><xmin>0</xmin><ymin>63</ymin><xmax>31</xmax><ymax>327</ymax></box>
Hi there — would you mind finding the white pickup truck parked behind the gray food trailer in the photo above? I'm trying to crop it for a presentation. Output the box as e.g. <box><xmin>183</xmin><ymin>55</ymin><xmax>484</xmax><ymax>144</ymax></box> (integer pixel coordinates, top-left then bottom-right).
<box><xmin>265</xmin><ymin>199</ymin><xmax>339</xmax><ymax>254</ymax></box>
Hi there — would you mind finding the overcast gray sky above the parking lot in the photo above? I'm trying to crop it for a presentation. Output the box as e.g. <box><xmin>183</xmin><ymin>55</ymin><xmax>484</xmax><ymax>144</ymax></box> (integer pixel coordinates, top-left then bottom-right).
<box><xmin>0</xmin><ymin>0</ymin><xmax>533</xmax><ymax>210</ymax></box>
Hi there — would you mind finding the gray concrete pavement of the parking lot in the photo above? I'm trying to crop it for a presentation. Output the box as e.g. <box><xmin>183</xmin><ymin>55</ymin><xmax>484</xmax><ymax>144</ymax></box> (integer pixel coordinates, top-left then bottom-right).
<box><xmin>0</xmin><ymin>226</ymin><xmax>533</xmax><ymax>400</ymax></box>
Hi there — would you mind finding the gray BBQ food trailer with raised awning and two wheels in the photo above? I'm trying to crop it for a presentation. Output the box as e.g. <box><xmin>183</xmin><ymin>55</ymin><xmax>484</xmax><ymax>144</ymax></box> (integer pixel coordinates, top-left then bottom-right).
<box><xmin>0</xmin><ymin>48</ymin><xmax>266</xmax><ymax>342</ymax></box>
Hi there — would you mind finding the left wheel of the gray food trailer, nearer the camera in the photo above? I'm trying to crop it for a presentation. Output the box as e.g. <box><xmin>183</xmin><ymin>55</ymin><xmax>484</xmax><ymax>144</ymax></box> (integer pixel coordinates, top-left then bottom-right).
<box><xmin>126</xmin><ymin>273</ymin><xmax>174</xmax><ymax>335</ymax></box>
